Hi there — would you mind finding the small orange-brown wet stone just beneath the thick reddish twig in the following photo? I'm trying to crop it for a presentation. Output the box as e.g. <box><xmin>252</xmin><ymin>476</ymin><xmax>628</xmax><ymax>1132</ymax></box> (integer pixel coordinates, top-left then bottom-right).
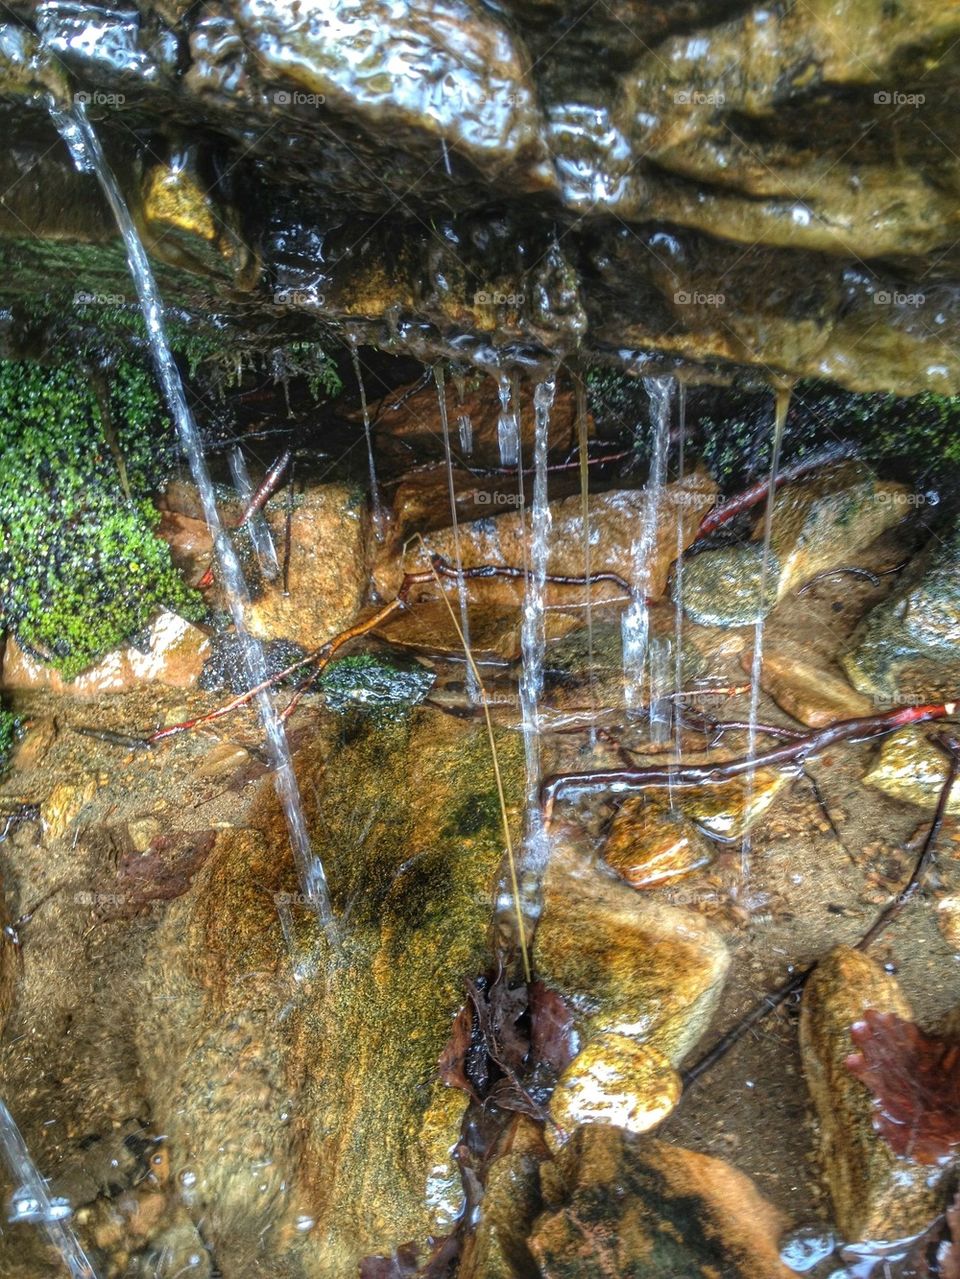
<box><xmin>603</xmin><ymin>796</ymin><xmax>713</xmax><ymax>888</ymax></box>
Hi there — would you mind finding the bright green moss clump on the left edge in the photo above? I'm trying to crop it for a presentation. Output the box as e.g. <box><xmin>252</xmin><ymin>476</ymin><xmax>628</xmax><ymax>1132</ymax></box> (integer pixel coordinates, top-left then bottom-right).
<box><xmin>0</xmin><ymin>361</ymin><xmax>202</xmax><ymax>678</ymax></box>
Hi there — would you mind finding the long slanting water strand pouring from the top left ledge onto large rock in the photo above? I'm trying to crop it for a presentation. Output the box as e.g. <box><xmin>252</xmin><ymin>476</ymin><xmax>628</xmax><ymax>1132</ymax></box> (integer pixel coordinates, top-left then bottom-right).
<box><xmin>50</xmin><ymin>102</ymin><xmax>335</xmax><ymax>946</ymax></box>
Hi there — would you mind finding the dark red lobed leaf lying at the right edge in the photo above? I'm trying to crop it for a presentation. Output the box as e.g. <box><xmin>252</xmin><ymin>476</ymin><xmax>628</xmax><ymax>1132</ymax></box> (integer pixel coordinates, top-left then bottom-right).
<box><xmin>846</xmin><ymin>1008</ymin><xmax>960</xmax><ymax>1164</ymax></box>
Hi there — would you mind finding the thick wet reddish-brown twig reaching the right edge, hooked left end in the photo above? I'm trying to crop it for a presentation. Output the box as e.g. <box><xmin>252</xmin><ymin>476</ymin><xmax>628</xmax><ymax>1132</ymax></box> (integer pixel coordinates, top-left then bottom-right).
<box><xmin>541</xmin><ymin>702</ymin><xmax>956</xmax><ymax>824</ymax></box>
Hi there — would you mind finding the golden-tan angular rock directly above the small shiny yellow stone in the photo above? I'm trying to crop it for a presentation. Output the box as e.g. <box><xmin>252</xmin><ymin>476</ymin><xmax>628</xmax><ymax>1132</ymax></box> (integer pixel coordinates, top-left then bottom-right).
<box><xmin>533</xmin><ymin>839</ymin><xmax>730</xmax><ymax>1065</ymax></box>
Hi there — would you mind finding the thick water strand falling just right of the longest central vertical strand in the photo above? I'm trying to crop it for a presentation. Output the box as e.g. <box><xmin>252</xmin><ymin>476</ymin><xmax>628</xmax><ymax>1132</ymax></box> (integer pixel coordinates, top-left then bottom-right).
<box><xmin>621</xmin><ymin>377</ymin><xmax>674</xmax><ymax>715</ymax></box>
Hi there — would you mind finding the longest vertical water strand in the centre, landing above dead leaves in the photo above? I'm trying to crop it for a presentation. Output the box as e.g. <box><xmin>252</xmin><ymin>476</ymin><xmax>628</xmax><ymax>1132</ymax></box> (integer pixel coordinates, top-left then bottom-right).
<box><xmin>520</xmin><ymin>379</ymin><xmax>556</xmax><ymax>916</ymax></box>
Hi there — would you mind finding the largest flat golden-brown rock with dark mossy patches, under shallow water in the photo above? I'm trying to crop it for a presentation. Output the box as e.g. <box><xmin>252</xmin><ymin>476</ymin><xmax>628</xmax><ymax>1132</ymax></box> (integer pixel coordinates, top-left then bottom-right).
<box><xmin>139</xmin><ymin>709</ymin><xmax>523</xmax><ymax>1279</ymax></box>
